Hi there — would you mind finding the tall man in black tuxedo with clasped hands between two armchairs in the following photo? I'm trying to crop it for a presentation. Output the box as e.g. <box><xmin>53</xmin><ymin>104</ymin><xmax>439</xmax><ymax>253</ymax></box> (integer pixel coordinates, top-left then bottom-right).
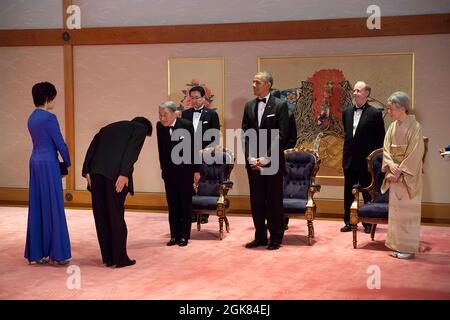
<box><xmin>242</xmin><ymin>71</ymin><xmax>289</xmax><ymax>250</ymax></box>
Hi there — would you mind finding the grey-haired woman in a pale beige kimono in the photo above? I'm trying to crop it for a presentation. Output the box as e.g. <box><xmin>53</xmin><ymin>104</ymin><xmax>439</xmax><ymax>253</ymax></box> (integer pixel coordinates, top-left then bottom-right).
<box><xmin>381</xmin><ymin>91</ymin><xmax>424</xmax><ymax>259</ymax></box>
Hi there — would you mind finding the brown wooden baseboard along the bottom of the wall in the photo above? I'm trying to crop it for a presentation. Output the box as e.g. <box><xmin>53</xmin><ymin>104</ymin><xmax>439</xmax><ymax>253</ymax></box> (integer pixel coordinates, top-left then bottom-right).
<box><xmin>0</xmin><ymin>188</ymin><xmax>450</xmax><ymax>224</ymax></box>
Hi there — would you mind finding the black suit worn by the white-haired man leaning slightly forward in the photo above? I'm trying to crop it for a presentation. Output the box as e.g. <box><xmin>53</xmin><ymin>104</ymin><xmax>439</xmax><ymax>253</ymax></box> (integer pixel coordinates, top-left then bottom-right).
<box><xmin>156</xmin><ymin>118</ymin><xmax>200</xmax><ymax>241</ymax></box>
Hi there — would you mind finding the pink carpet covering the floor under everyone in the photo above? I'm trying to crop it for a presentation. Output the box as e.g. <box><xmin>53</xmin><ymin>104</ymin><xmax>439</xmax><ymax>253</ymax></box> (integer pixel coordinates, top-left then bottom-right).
<box><xmin>0</xmin><ymin>207</ymin><xmax>450</xmax><ymax>300</ymax></box>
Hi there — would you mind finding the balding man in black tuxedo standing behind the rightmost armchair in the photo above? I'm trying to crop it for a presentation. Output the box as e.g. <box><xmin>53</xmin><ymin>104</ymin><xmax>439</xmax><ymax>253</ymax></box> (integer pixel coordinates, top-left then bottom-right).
<box><xmin>341</xmin><ymin>81</ymin><xmax>385</xmax><ymax>233</ymax></box>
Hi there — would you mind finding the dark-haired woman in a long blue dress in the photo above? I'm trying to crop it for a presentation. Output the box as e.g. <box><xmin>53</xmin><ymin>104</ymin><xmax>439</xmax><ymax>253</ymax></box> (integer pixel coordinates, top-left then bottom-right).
<box><xmin>25</xmin><ymin>82</ymin><xmax>71</xmax><ymax>265</ymax></box>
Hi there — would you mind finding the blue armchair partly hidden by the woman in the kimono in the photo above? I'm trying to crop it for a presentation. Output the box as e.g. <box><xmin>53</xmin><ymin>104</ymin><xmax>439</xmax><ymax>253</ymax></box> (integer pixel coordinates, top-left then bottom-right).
<box><xmin>350</xmin><ymin>148</ymin><xmax>389</xmax><ymax>249</ymax></box>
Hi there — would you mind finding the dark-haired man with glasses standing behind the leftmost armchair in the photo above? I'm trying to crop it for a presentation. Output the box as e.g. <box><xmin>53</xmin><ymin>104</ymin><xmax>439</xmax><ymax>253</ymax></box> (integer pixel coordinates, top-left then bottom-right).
<box><xmin>181</xmin><ymin>86</ymin><xmax>220</xmax><ymax>223</ymax></box>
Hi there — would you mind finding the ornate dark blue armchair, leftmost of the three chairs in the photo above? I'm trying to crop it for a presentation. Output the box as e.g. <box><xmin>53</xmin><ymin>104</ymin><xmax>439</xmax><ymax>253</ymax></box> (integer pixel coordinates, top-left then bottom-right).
<box><xmin>192</xmin><ymin>146</ymin><xmax>234</xmax><ymax>240</ymax></box>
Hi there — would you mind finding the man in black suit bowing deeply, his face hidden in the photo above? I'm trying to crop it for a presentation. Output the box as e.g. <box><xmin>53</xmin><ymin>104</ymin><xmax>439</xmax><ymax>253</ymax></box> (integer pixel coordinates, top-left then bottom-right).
<box><xmin>82</xmin><ymin>117</ymin><xmax>153</xmax><ymax>268</ymax></box>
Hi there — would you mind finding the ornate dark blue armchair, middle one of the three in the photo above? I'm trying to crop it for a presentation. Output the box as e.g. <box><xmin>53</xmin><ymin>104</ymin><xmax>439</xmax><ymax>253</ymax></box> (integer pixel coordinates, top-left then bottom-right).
<box><xmin>283</xmin><ymin>148</ymin><xmax>320</xmax><ymax>245</ymax></box>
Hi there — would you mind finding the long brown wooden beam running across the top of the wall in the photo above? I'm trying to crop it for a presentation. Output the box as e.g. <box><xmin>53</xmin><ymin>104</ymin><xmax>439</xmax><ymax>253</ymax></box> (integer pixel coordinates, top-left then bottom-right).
<box><xmin>0</xmin><ymin>13</ymin><xmax>450</xmax><ymax>46</ymax></box>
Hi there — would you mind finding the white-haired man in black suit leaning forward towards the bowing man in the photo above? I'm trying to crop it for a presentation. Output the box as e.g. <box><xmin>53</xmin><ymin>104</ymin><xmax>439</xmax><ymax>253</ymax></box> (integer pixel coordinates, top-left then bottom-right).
<box><xmin>156</xmin><ymin>101</ymin><xmax>200</xmax><ymax>247</ymax></box>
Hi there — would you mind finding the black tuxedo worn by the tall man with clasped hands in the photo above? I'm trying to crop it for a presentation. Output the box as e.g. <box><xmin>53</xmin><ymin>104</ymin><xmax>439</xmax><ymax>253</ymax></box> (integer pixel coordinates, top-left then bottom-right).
<box><xmin>242</xmin><ymin>95</ymin><xmax>289</xmax><ymax>243</ymax></box>
